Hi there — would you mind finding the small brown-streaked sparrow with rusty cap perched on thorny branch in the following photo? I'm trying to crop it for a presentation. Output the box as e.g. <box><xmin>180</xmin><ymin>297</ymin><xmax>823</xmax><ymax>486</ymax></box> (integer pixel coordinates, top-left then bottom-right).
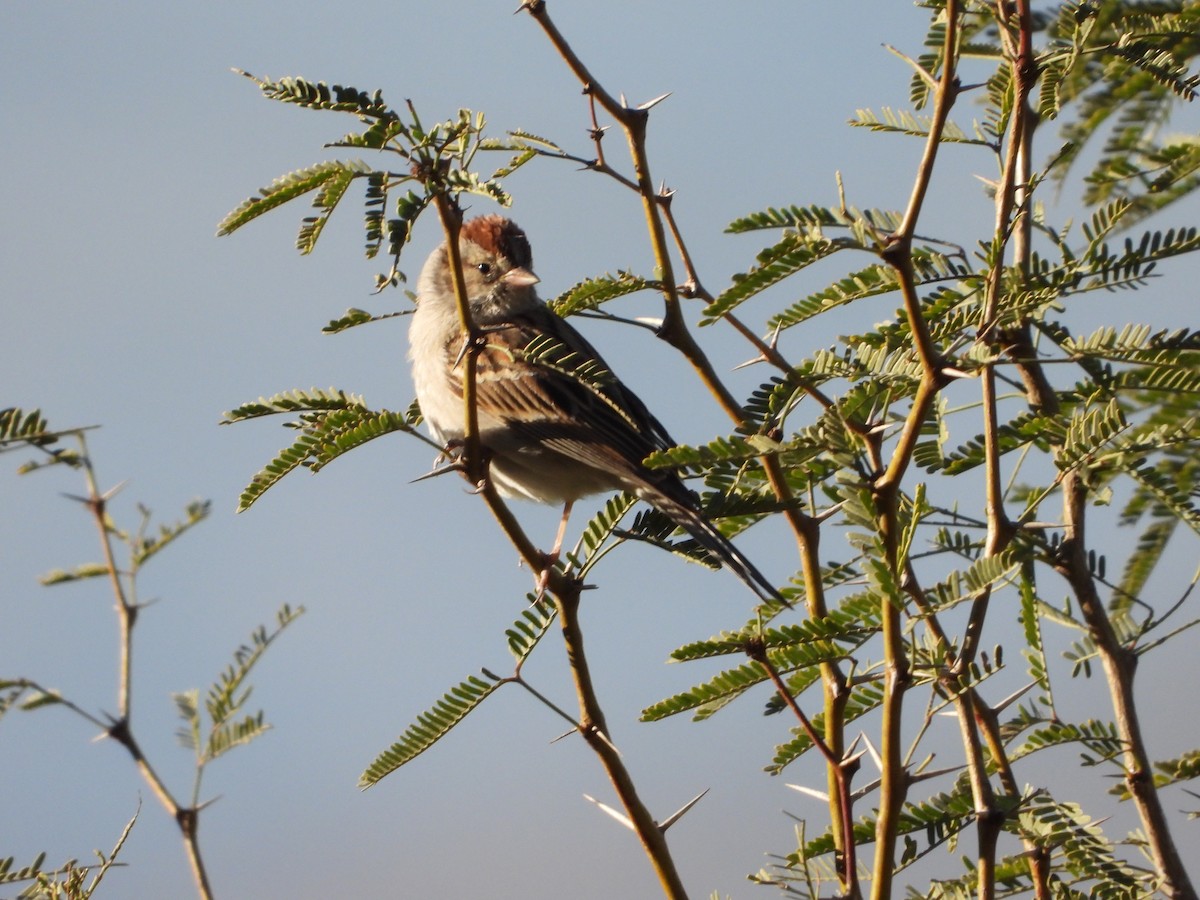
<box><xmin>408</xmin><ymin>215</ymin><xmax>781</xmax><ymax>600</ymax></box>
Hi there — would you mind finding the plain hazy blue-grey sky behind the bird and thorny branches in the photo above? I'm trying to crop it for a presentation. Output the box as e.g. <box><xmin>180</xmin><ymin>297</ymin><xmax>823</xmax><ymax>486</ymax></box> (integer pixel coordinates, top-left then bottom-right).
<box><xmin>0</xmin><ymin>0</ymin><xmax>1200</xmax><ymax>900</ymax></box>
